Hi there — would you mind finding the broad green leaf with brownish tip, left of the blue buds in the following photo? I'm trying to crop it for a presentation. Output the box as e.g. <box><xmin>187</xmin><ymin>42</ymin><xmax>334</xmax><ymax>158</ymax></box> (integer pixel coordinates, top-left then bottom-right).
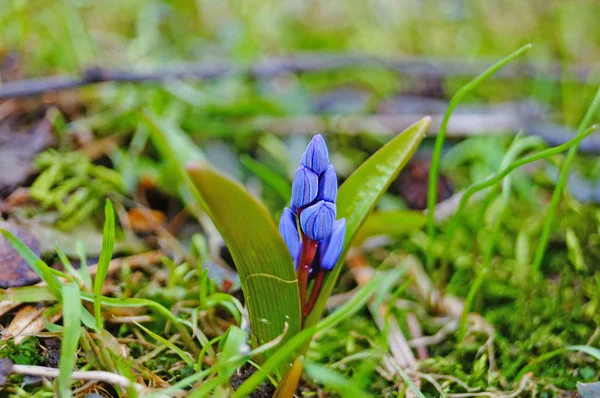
<box><xmin>187</xmin><ymin>163</ymin><xmax>301</xmax><ymax>360</ymax></box>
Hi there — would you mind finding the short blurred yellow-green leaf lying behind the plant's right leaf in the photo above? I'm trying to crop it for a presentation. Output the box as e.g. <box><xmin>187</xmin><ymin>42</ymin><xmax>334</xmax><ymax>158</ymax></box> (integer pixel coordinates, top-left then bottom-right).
<box><xmin>353</xmin><ymin>210</ymin><xmax>427</xmax><ymax>245</ymax></box>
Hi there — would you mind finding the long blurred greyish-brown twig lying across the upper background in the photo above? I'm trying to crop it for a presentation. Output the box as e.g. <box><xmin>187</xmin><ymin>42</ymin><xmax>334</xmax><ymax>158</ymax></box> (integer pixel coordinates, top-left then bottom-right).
<box><xmin>0</xmin><ymin>53</ymin><xmax>597</xmax><ymax>100</ymax></box>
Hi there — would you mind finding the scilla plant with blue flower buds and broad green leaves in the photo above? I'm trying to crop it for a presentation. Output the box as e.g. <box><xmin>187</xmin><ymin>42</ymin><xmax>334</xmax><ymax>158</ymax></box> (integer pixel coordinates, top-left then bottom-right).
<box><xmin>146</xmin><ymin>116</ymin><xmax>431</xmax><ymax>378</ymax></box>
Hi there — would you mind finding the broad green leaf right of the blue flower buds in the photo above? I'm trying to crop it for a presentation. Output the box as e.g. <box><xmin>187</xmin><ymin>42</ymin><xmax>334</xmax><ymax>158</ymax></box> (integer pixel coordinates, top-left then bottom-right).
<box><xmin>304</xmin><ymin>117</ymin><xmax>431</xmax><ymax>326</ymax></box>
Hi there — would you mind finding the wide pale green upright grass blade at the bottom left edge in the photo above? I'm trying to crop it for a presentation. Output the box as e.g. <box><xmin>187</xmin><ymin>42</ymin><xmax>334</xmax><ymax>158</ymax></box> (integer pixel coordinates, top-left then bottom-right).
<box><xmin>58</xmin><ymin>283</ymin><xmax>81</xmax><ymax>398</ymax></box>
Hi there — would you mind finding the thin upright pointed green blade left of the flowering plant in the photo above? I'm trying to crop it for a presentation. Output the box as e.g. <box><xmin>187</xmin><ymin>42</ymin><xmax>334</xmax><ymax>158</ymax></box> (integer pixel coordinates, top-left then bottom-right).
<box><xmin>94</xmin><ymin>200</ymin><xmax>115</xmax><ymax>330</ymax></box>
